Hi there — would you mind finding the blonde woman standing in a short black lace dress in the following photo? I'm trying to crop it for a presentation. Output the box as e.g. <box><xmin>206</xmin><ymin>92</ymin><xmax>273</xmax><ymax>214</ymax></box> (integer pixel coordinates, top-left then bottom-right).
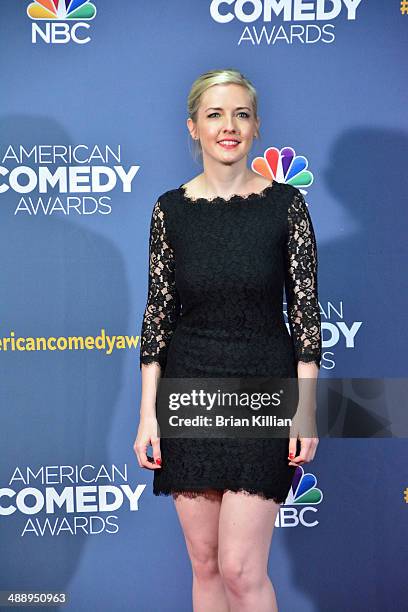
<box><xmin>134</xmin><ymin>70</ymin><xmax>321</xmax><ymax>612</ymax></box>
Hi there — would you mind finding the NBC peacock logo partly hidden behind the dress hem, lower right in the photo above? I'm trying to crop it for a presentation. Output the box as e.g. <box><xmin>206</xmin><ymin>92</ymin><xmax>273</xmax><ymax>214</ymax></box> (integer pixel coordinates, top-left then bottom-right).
<box><xmin>275</xmin><ymin>465</ymin><xmax>323</xmax><ymax>527</ymax></box>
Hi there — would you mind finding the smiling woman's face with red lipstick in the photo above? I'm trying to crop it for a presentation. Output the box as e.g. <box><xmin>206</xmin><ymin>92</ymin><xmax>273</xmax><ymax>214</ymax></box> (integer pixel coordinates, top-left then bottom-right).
<box><xmin>187</xmin><ymin>84</ymin><xmax>259</xmax><ymax>164</ymax></box>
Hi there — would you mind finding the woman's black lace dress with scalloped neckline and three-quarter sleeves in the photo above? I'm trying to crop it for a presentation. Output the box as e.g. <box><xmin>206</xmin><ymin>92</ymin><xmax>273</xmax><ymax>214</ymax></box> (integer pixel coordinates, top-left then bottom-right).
<box><xmin>140</xmin><ymin>181</ymin><xmax>321</xmax><ymax>503</ymax></box>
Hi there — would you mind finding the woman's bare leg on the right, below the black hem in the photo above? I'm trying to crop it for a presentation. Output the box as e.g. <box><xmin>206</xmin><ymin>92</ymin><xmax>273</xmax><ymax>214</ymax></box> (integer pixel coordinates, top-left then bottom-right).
<box><xmin>219</xmin><ymin>491</ymin><xmax>280</xmax><ymax>612</ymax></box>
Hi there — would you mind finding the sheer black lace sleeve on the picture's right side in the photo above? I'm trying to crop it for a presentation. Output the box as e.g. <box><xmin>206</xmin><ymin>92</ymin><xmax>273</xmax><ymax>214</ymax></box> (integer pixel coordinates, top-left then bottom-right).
<box><xmin>285</xmin><ymin>190</ymin><xmax>321</xmax><ymax>369</ymax></box>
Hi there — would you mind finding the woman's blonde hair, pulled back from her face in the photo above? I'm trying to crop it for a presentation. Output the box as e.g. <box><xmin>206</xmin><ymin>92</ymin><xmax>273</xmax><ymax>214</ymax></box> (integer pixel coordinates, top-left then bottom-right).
<box><xmin>187</xmin><ymin>68</ymin><xmax>258</xmax><ymax>160</ymax></box>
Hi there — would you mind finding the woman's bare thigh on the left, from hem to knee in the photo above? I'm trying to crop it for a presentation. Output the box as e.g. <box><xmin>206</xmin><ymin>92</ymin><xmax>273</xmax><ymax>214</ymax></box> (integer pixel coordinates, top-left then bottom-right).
<box><xmin>173</xmin><ymin>490</ymin><xmax>223</xmax><ymax>565</ymax></box>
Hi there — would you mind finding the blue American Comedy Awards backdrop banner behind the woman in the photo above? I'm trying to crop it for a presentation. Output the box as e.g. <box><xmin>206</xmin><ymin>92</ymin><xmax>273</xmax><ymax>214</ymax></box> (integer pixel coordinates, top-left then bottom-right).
<box><xmin>0</xmin><ymin>0</ymin><xmax>408</xmax><ymax>612</ymax></box>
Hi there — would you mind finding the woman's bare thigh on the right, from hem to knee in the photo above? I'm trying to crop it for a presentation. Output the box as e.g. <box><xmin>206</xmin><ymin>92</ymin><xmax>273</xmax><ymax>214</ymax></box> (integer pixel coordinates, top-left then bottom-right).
<box><xmin>218</xmin><ymin>491</ymin><xmax>280</xmax><ymax>577</ymax></box>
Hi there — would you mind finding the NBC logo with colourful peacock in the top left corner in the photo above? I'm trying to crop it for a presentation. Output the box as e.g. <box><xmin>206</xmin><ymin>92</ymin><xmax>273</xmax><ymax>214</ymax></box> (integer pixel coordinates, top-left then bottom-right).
<box><xmin>27</xmin><ymin>0</ymin><xmax>96</xmax><ymax>45</ymax></box>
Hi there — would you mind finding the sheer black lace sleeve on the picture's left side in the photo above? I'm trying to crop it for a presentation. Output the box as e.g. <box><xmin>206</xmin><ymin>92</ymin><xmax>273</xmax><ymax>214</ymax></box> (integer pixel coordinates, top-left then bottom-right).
<box><xmin>140</xmin><ymin>200</ymin><xmax>180</xmax><ymax>370</ymax></box>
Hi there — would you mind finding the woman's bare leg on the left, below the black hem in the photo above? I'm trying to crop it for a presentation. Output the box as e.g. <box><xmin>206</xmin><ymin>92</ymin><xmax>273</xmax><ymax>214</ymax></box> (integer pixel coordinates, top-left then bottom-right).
<box><xmin>173</xmin><ymin>490</ymin><xmax>229</xmax><ymax>612</ymax></box>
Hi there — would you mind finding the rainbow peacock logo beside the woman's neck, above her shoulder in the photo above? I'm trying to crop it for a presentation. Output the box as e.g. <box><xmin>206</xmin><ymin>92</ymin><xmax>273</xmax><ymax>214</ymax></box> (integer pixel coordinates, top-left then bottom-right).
<box><xmin>251</xmin><ymin>147</ymin><xmax>313</xmax><ymax>195</ymax></box>
